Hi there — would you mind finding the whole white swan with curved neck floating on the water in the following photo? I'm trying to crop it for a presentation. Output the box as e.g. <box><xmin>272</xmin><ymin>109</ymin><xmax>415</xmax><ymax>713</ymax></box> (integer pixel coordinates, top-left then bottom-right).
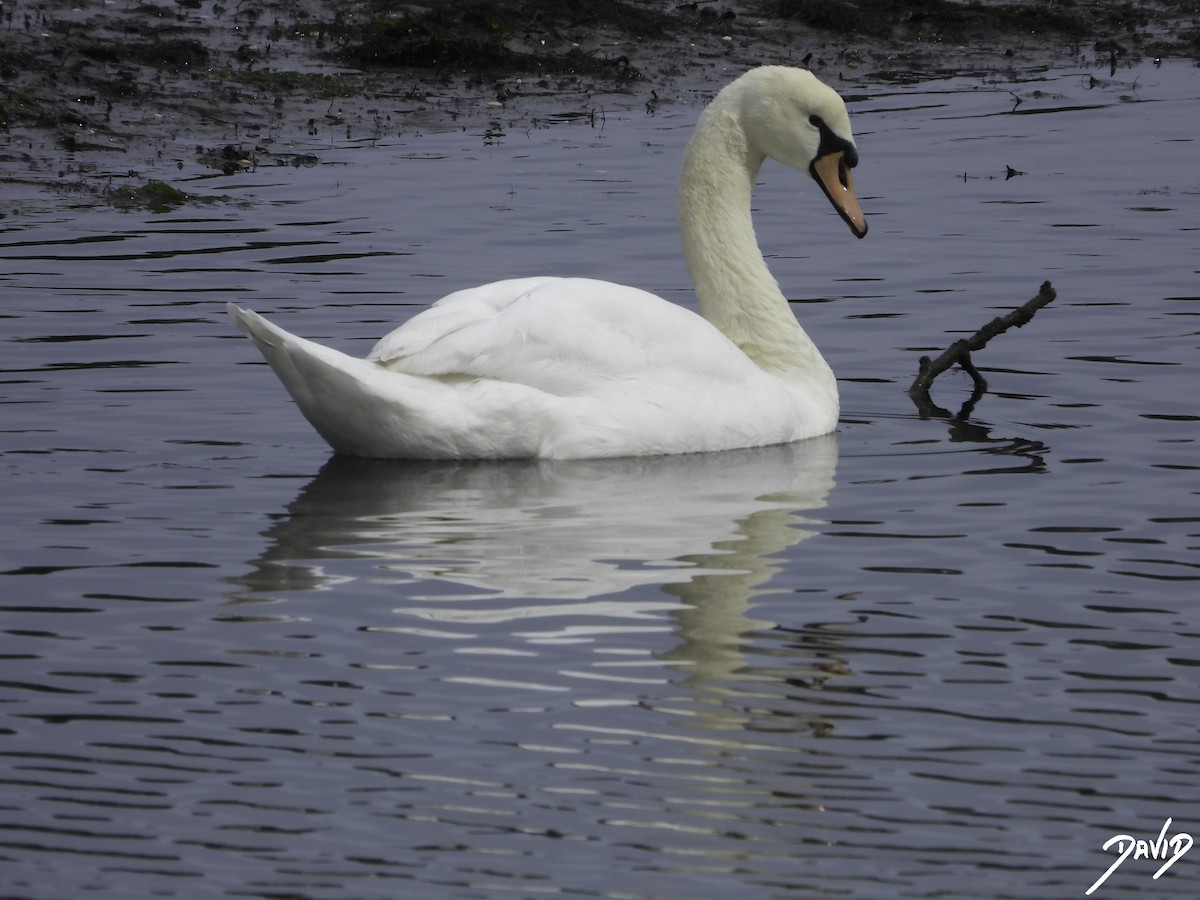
<box><xmin>229</xmin><ymin>66</ymin><xmax>866</xmax><ymax>458</ymax></box>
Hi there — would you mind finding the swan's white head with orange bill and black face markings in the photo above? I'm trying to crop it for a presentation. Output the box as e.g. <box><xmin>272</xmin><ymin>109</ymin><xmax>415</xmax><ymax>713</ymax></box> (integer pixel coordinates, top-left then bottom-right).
<box><xmin>738</xmin><ymin>66</ymin><xmax>866</xmax><ymax>238</ymax></box>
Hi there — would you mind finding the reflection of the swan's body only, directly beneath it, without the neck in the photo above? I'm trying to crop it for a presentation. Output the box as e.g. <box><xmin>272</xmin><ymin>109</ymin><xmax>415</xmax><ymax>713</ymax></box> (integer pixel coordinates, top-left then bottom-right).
<box><xmin>231</xmin><ymin>436</ymin><xmax>838</xmax><ymax>607</ymax></box>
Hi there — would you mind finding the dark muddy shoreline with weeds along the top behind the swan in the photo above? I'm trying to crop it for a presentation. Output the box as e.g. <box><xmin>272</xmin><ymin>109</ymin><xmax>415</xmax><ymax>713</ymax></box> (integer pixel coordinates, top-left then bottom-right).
<box><xmin>0</xmin><ymin>0</ymin><xmax>1200</xmax><ymax>215</ymax></box>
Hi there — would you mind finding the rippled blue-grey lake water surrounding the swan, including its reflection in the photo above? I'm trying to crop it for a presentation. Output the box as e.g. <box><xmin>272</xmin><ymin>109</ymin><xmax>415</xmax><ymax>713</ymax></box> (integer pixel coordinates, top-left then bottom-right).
<box><xmin>0</xmin><ymin>54</ymin><xmax>1200</xmax><ymax>900</ymax></box>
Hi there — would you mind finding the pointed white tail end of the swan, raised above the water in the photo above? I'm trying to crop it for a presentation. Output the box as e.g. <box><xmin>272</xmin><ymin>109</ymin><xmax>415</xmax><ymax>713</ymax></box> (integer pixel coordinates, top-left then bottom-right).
<box><xmin>228</xmin><ymin>304</ymin><xmax>441</xmax><ymax>457</ymax></box>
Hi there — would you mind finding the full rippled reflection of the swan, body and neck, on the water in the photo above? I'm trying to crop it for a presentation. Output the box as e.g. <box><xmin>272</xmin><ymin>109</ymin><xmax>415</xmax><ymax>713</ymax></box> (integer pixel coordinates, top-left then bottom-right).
<box><xmin>235</xmin><ymin>436</ymin><xmax>838</xmax><ymax>731</ymax></box>
